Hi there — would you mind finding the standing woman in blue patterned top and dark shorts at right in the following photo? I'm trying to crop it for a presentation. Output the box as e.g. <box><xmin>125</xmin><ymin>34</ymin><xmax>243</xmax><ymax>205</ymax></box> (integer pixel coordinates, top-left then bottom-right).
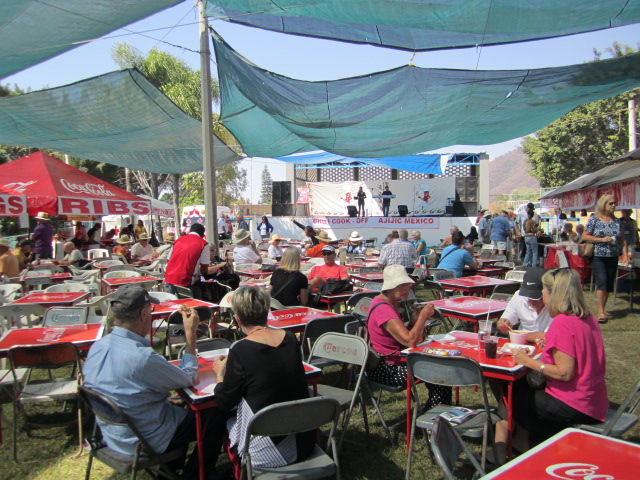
<box><xmin>582</xmin><ymin>195</ymin><xmax>627</xmax><ymax>323</ymax></box>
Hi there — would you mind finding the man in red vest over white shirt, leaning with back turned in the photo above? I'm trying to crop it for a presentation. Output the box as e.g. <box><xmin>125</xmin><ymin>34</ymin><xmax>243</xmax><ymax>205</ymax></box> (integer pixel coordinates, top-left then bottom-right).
<box><xmin>164</xmin><ymin>223</ymin><xmax>211</xmax><ymax>294</ymax></box>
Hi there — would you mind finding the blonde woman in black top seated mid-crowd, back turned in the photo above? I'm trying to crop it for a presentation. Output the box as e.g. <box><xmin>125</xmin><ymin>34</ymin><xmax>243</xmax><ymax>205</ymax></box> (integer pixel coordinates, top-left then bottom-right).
<box><xmin>269</xmin><ymin>247</ymin><xmax>309</xmax><ymax>306</ymax></box>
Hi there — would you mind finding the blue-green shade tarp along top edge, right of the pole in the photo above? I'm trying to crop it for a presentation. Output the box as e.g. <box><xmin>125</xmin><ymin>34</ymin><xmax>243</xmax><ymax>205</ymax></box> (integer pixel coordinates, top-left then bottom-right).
<box><xmin>205</xmin><ymin>0</ymin><xmax>640</xmax><ymax>51</ymax></box>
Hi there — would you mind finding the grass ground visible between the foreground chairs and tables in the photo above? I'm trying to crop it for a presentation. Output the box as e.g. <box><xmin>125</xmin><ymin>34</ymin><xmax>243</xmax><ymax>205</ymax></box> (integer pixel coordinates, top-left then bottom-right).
<box><xmin>0</xmin><ymin>284</ymin><xmax>640</xmax><ymax>480</ymax></box>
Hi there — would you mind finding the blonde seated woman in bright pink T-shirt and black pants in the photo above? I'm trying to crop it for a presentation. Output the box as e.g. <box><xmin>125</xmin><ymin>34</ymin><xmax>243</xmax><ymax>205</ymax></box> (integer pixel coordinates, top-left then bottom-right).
<box><xmin>496</xmin><ymin>268</ymin><xmax>609</xmax><ymax>460</ymax></box>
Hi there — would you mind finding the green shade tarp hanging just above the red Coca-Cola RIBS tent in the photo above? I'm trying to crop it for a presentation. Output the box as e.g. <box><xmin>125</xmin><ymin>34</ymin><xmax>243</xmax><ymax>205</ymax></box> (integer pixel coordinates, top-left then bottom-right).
<box><xmin>0</xmin><ymin>70</ymin><xmax>240</xmax><ymax>173</ymax></box>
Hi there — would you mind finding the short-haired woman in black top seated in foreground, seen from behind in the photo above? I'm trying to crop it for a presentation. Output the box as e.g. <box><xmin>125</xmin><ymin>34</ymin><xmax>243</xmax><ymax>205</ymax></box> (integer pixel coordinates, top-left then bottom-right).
<box><xmin>212</xmin><ymin>286</ymin><xmax>316</xmax><ymax>467</ymax></box>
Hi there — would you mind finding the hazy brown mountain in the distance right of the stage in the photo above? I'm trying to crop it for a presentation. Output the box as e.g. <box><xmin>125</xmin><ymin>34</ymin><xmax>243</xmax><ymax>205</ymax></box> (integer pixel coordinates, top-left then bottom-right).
<box><xmin>489</xmin><ymin>147</ymin><xmax>540</xmax><ymax>200</ymax></box>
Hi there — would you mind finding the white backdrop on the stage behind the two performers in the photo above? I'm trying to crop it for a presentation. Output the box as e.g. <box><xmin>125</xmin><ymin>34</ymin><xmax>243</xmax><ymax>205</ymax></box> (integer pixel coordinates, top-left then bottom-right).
<box><xmin>308</xmin><ymin>177</ymin><xmax>456</xmax><ymax>217</ymax></box>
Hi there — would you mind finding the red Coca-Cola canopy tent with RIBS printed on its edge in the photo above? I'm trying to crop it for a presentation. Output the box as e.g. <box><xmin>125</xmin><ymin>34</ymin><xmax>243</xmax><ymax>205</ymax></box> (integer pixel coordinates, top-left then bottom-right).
<box><xmin>0</xmin><ymin>152</ymin><xmax>151</xmax><ymax>216</ymax></box>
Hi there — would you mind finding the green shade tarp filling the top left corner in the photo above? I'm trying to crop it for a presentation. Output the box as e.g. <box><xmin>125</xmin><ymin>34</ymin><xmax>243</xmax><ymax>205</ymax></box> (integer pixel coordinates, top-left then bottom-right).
<box><xmin>0</xmin><ymin>0</ymin><xmax>179</xmax><ymax>78</ymax></box>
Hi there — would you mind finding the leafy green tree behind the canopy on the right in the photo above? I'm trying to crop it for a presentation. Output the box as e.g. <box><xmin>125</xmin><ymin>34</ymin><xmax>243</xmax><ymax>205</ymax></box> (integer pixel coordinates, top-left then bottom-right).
<box><xmin>522</xmin><ymin>43</ymin><xmax>640</xmax><ymax>187</ymax></box>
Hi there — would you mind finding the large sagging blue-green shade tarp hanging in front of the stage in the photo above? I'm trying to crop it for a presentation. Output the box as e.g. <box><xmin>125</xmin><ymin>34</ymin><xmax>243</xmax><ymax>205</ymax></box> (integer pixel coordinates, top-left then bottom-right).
<box><xmin>213</xmin><ymin>34</ymin><xmax>640</xmax><ymax>159</ymax></box>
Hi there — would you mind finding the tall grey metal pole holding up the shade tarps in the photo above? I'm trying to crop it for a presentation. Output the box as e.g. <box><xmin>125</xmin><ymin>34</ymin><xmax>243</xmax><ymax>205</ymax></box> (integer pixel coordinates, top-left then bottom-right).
<box><xmin>198</xmin><ymin>1</ymin><xmax>218</xmax><ymax>245</ymax></box>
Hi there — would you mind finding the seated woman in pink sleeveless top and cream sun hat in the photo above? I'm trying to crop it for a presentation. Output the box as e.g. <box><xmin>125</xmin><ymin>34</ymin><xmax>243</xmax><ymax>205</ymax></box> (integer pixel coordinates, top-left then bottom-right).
<box><xmin>367</xmin><ymin>265</ymin><xmax>451</xmax><ymax>409</ymax></box>
